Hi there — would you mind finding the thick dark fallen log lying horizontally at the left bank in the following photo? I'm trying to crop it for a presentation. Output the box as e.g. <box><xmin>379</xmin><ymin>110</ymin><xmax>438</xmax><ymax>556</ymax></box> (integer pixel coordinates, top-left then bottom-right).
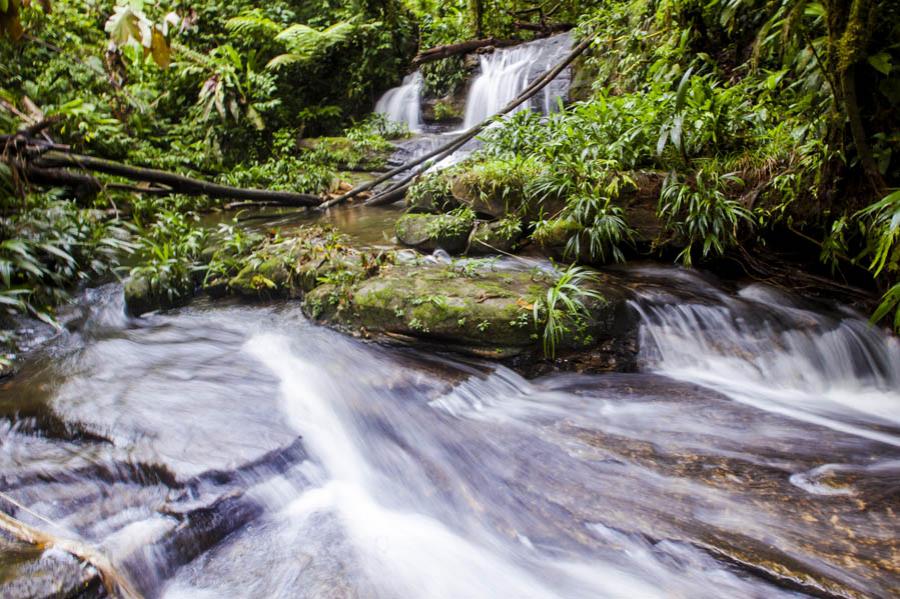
<box><xmin>0</xmin><ymin>132</ymin><xmax>322</xmax><ymax>207</ymax></box>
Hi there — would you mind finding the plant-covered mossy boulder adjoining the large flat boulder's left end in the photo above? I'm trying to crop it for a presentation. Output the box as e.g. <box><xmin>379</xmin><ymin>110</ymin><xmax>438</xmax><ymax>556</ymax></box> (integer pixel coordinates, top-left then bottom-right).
<box><xmin>228</xmin><ymin>226</ymin><xmax>368</xmax><ymax>298</ymax></box>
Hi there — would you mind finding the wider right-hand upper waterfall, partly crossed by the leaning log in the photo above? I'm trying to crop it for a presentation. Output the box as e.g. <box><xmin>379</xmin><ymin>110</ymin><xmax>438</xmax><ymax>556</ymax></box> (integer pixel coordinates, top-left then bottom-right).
<box><xmin>465</xmin><ymin>34</ymin><xmax>572</xmax><ymax>129</ymax></box>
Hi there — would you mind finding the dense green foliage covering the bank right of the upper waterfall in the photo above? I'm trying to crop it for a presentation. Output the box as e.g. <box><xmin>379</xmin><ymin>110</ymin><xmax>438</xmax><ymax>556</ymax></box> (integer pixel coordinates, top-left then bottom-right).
<box><xmin>454</xmin><ymin>0</ymin><xmax>900</xmax><ymax>322</ymax></box>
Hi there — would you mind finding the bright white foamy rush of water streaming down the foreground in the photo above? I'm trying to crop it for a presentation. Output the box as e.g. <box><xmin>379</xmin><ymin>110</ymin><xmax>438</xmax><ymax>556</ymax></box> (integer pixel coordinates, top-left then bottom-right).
<box><xmin>223</xmin><ymin>334</ymin><xmax>796</xmax><ymax>599</ymax></box>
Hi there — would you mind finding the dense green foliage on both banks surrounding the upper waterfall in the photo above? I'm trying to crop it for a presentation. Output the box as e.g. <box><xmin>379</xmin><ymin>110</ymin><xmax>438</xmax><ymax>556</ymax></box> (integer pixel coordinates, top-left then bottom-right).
<box><xmin>0</xmin><ymin>0</ymin><xmax>900</xmax><ymax>349</ymax></box>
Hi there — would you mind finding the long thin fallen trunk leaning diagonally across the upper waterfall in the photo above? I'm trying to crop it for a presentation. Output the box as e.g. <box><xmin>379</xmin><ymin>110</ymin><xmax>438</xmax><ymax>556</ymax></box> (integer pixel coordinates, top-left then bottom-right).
<box><xmin>319</xmin><ymin>39</ymin><xmax>591</xmax><ymax>210</ymax></box>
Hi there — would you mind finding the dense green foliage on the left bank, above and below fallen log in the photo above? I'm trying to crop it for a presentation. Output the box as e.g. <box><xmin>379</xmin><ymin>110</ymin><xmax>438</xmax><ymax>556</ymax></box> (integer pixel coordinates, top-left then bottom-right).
<box><xmin>0</xmin><ymin>0</ymin><xmax>415</xmax><ymax>340</ymax></box>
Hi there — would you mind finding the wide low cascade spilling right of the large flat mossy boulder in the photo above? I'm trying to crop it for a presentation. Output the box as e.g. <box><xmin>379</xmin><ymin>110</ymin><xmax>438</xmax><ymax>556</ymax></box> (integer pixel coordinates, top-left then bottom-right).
<box><xmin>634</xmin><ymin>280</ymin><xmax>900</xmax><ymax>446</ymax></box>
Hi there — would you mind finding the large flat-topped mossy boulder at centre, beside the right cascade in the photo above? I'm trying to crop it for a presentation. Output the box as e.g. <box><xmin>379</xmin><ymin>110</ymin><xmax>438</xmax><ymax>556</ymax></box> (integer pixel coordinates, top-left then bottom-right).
<box><xmin>304</xmin><ymin>261</ymin><xmax>633</xmax><ymax>357</ymax></box>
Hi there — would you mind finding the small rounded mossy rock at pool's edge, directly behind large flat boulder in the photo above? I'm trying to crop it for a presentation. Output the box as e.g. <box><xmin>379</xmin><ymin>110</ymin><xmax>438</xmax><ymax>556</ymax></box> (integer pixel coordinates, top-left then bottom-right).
<box><xmin>395</xmin><ymin>210</ymin><xmax>475</xmax><ymax>254</ymax></box>
